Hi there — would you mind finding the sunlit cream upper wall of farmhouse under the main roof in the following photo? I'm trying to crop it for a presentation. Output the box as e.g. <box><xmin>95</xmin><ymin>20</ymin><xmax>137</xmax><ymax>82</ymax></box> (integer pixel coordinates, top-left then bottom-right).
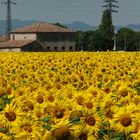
<box><xmin>10</xmin><ymin>33</ymin><xmax>36</xmax><ymax>40</ymax></box>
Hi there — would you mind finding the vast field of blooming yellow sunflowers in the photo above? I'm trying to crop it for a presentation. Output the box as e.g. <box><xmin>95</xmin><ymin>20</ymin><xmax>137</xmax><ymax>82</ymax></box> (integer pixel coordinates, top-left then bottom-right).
<box><xmin>0</xmin><ymin>52</ymin><xmax>140</xmax><ymax>140</ymax></box>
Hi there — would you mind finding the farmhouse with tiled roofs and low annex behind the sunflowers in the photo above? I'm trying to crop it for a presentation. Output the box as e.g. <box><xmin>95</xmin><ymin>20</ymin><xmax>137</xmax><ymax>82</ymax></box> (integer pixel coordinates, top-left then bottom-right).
<box><xmin>0</xmin><ymin>22</ymin><xmax>75</xmax><ymax>51</ymax></box>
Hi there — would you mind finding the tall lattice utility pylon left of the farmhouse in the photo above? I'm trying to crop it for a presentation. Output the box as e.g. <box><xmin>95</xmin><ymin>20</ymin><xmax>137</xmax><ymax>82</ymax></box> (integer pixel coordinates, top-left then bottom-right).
<box><xmin>2</xmin><ymin>0</ymin><xmax>16</xmax><ymax>40</ymax></box>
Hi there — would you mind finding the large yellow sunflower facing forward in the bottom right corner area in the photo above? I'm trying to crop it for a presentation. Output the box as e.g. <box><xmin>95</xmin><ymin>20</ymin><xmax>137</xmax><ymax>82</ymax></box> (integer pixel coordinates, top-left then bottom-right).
<box><xmin>111</xmin><ymin>104</ymin><xmax>138</xmax><ymax>134</ymax></box>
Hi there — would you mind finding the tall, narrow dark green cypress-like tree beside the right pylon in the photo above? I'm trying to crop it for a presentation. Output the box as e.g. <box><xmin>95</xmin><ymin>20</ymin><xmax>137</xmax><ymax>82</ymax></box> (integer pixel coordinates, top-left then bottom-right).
<box><xmin>99</xmin><ymin>9</ymin><xmax>114</xmax><ymax>51</ymax></box>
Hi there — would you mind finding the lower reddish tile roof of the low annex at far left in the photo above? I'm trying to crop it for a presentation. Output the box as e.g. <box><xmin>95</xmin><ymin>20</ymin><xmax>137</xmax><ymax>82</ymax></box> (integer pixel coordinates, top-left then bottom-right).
<box><xmin>0</xmin><ymin>40</ymin><xmax>34</xmax><ymax>48</ymax></box>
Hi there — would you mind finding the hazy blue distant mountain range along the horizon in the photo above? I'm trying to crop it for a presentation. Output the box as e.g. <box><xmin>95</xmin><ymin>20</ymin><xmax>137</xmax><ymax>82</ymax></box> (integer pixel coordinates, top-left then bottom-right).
<box><xmin>0</xmin><ymin>19</ymin><xmax>140</xmax><ymax>35</ymax></box>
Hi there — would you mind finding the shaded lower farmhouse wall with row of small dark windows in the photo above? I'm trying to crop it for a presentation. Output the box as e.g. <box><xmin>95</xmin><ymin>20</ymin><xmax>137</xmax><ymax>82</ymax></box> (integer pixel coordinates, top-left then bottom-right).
<box><xmin>42</xmin><ymin>41</ymin><xmax>75</xmax><ymax>51</ymax></box>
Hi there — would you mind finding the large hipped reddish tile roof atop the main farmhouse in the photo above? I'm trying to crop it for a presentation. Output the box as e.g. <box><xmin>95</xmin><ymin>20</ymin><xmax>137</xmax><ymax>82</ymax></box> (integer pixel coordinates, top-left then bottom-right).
<box><xmin>11</xmin><ymin>22</ymin><xmax>74</xmax><ymax>33</ymax></box>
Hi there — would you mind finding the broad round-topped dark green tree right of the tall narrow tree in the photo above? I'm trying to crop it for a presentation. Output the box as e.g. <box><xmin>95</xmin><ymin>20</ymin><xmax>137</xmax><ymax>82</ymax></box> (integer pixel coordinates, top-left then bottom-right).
<box><xmin>117</xmin><ymin>28</ymin><xmax>137</xmax><ymax>51</ymax></box>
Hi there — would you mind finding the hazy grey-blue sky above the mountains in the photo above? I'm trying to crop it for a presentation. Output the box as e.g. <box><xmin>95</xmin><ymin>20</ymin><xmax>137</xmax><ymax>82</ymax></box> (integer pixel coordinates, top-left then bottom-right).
<box><xmin>0</xmin><ymin>0</ymin><xmax>140</xmax><ymax>25</ymax></box>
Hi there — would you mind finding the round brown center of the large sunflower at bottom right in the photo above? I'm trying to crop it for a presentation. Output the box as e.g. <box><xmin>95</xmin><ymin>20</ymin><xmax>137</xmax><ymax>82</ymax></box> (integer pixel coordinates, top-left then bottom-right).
<box><xmin>119</xmin><ymin>114</ymin><xmax>132</xmax><ymax>127</ymax></box>
